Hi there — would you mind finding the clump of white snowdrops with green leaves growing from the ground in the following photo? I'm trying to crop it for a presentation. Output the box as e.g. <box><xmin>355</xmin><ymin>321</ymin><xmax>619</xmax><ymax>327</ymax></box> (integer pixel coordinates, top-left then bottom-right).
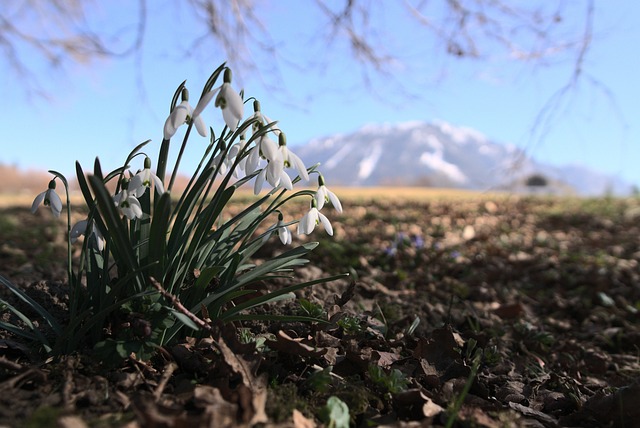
<box><xmin>0</xmin><ymin>64</ymin><xmax>342</xmax><ymax>359</ymax></box>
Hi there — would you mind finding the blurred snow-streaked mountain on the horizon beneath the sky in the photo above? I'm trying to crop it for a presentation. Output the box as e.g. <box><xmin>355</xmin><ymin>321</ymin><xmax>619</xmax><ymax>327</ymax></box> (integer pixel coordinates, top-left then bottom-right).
<box><xmin>295</xmin><ymin>122</ymin><xmax>631</xmax><ymax>195</ymax></box>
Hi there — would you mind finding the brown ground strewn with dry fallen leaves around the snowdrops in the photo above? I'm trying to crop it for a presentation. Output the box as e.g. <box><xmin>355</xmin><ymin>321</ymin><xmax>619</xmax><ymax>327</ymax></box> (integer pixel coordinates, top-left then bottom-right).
<box><xmin>0</xmin><ymin>195</ymin><xmax>640</xmax><ymax>428</ymax></box>
